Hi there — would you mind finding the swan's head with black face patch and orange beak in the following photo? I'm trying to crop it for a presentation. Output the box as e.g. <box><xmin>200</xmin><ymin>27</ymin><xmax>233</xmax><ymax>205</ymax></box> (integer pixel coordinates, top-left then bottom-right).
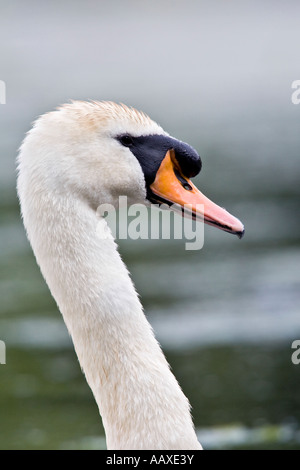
<box><xmin>19</xmin><ymin>101</ymin><xmax>244</xmax><ymax>237</ymax></box>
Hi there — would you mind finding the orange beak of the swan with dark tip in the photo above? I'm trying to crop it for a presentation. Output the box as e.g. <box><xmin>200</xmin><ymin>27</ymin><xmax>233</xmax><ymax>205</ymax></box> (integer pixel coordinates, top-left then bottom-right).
<box><xmin>150</xmin><ymin>149</ymin><xmax>244</xmax><ymax>238</ymax></box>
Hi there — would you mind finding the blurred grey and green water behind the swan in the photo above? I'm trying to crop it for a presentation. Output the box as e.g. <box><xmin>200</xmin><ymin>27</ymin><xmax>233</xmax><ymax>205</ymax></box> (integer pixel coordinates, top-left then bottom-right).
<box><xmin>0</xmin><ymin>0</ymin><xmax>300</xmax><ymax>449</ymax></box>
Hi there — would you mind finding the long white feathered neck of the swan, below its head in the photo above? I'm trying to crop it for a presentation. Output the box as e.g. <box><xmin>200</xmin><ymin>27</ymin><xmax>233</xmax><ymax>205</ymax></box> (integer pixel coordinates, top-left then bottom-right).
<box><xmin>24</xmin><ymin>192</ymin><xmax>201</xmax><ymax>449</ymax></box>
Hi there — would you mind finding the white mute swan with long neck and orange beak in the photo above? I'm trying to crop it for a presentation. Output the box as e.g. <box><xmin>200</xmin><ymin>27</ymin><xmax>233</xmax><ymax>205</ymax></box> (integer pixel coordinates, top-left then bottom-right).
<box><xmin>17</xmin><ymin>101</ymin><xmax>244</xmax><ymax>450</ymax></box>
